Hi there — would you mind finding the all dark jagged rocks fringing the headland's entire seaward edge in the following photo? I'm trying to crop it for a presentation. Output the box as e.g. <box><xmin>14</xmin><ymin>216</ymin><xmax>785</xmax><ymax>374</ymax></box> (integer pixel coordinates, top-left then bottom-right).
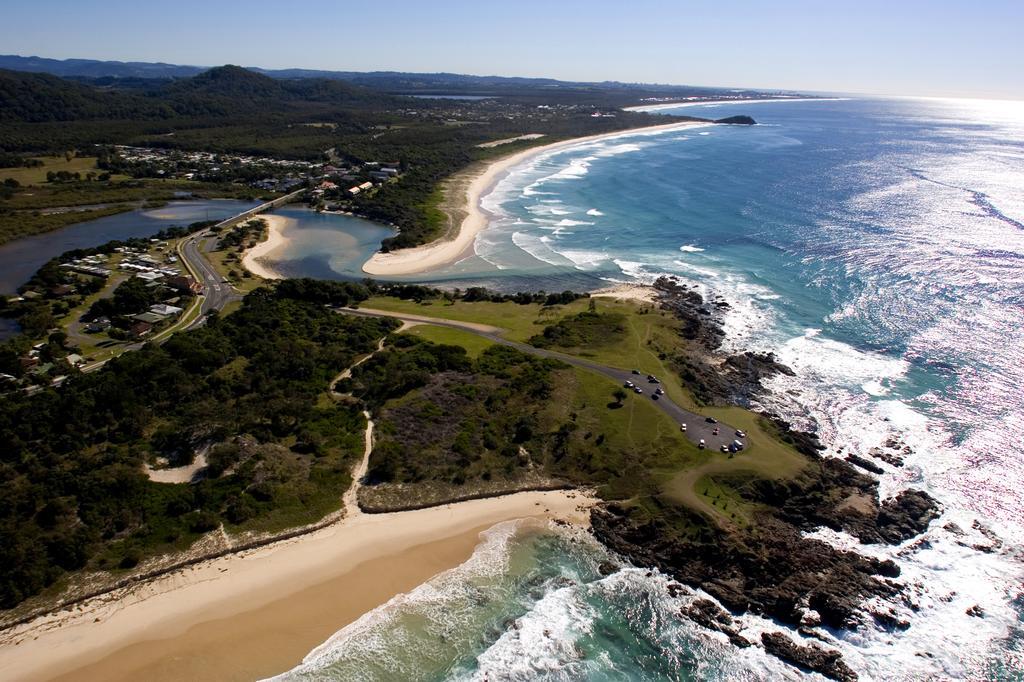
<box><xmin>592</xmin><ymin>278</ymin><xmax>939</xmax><ymax>680</ymax></box>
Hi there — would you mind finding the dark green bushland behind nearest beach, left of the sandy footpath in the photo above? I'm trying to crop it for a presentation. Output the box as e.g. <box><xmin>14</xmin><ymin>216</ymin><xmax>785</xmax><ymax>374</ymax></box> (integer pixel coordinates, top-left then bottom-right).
<box><xmin>0</xmin><ymin>283</ymin><xmax>396</xmax><ymax>607</ymax></box>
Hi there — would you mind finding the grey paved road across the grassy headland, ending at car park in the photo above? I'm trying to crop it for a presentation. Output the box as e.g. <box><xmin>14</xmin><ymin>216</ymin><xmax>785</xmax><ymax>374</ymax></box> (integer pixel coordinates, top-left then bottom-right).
<box><xmin>339</xmin><ymin>308</ymin><xmax>745</xmax><ymax>452</ymax></box>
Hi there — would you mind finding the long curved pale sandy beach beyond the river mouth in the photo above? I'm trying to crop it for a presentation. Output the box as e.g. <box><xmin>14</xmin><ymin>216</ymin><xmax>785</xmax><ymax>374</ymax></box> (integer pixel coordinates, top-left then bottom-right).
<box><xmin>362</xmin><ymin>121</ymin><xmax>708</xmax><ymax>276</ymax></box>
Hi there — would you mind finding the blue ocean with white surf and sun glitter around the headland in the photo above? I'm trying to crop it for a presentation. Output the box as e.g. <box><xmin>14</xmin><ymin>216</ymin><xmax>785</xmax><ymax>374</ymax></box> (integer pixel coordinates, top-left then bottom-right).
<box><xmin>266</xmin><ymin>98</ymin><xmax>1024</xmax><ymax>680</ymax></box>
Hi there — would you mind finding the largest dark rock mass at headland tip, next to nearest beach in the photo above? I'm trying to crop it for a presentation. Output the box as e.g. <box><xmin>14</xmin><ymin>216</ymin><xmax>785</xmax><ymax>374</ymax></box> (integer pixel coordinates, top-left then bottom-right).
<box><xmin>591</xmin><ymin>451</ymin><xmax>938</xmax><ymax>680</ymax></box>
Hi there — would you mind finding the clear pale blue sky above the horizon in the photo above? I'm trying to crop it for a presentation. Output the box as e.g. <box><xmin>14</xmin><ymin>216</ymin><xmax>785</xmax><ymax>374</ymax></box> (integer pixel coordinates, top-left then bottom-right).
<box><xmin>0</xmin><ymin>0</ymin><xmax>1024</xmax><ymax>99</ymax></box>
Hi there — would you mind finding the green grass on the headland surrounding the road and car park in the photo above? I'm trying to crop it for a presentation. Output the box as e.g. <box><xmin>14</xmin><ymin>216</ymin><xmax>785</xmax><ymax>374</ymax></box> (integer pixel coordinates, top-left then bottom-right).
<box><xmin>364</xmin><ymin>297</ymin><xmax>808</xmax><ymax>525</ymax></box>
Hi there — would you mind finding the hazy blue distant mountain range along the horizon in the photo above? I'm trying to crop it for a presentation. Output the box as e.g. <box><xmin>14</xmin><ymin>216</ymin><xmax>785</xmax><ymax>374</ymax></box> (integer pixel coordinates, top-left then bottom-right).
<box><xmin>0</xmin><ymin>54</ymin><xmax>778</xmax><ymax>96</ymax></box>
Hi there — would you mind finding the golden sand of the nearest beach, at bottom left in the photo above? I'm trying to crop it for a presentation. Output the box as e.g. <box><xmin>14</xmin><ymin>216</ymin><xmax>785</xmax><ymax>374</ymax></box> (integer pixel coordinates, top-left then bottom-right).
<box><xmin>0</xmin><ymin>491</ymin><xmax>592</xmax><ymax>681</ymax></box>
